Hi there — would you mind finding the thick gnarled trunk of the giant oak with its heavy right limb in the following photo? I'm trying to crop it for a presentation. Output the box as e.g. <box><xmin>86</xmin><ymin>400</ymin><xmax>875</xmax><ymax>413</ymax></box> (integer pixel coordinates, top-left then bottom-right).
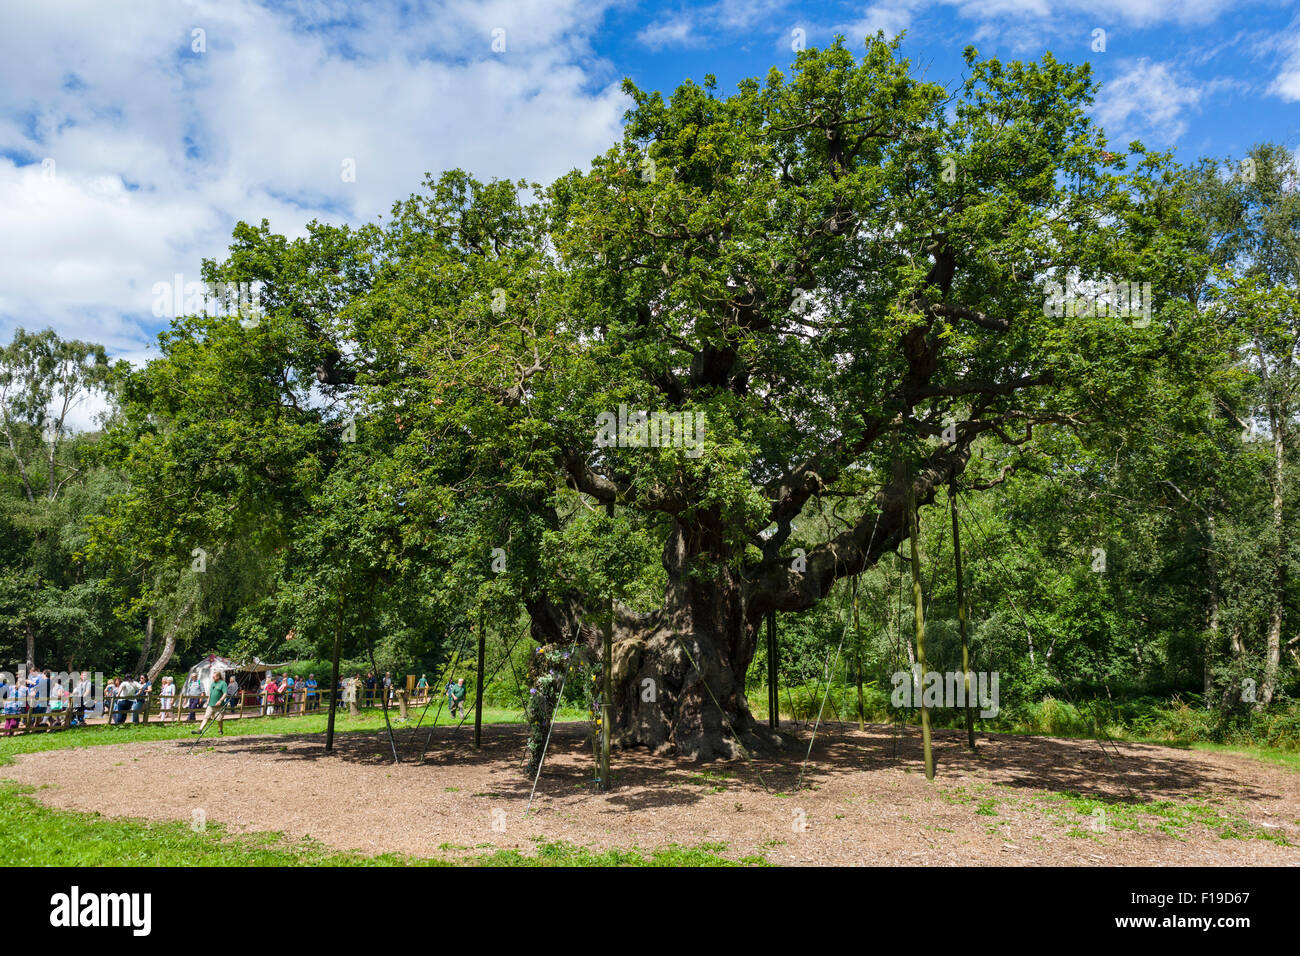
<box><xmin>540</xmin><ymin>445</ymin><xmax>969</xmax><ymax>760</ymax></box>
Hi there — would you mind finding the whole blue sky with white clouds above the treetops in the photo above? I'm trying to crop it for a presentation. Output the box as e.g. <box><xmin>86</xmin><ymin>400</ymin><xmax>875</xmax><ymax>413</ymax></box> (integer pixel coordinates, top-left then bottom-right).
<box><xmin>0</xmin><ymin>0</ymin><xmax>1300</xmax><ymax>426</ymax></box>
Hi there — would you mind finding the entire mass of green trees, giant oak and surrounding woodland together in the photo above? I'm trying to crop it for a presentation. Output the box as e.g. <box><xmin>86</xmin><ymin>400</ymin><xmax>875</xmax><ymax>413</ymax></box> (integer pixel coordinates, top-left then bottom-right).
<box><xmin>0</xmin><ymin>40</ymin><xmax>1300</xmax><ymax>756</ymax></box>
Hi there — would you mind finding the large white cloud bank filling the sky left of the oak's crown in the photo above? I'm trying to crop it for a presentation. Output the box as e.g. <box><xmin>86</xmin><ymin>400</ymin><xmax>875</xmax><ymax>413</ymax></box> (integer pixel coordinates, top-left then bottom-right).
<box><xmin>0</xmin><ymin>0</ymin><xmax>627</xmax><ymax>356</ymax></box>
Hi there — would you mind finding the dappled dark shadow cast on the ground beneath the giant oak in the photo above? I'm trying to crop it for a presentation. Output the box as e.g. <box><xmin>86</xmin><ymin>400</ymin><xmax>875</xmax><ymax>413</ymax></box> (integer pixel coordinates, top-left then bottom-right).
<box><xmin>181</xmin><ymin>722</ymin><xmax>1269</xmax><ymax>809</ymax></box>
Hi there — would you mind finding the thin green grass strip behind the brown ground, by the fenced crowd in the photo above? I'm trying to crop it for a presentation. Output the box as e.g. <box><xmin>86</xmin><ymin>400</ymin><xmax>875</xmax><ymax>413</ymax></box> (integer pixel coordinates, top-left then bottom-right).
<box><xmin>0</xmin><ymin>704</ymin><xmax>586</xmax><ymax>766</ymax></box>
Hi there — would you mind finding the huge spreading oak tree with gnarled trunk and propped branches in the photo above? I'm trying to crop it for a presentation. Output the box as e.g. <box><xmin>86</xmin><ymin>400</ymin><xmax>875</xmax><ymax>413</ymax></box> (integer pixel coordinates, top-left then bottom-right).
<box><xmin>111</xmin><ymin>39</ymin><xmax>1196</xmax><ymax>757</ymax></box>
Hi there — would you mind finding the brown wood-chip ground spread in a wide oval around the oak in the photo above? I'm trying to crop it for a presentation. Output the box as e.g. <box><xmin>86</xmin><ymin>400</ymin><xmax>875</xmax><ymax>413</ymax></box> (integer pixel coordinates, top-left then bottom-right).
<box><xmin>0</xmin><ymin>724</ymin><xmax>1300</xmax><ymax>866</ymax></box>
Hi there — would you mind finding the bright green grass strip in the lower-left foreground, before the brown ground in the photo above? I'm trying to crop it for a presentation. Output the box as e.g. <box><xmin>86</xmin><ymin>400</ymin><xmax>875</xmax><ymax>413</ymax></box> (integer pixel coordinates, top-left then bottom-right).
<box><xmin>0</xmin><ymin>782</ymin><xmax>770</xmax><ymax>866</ymax></box>
